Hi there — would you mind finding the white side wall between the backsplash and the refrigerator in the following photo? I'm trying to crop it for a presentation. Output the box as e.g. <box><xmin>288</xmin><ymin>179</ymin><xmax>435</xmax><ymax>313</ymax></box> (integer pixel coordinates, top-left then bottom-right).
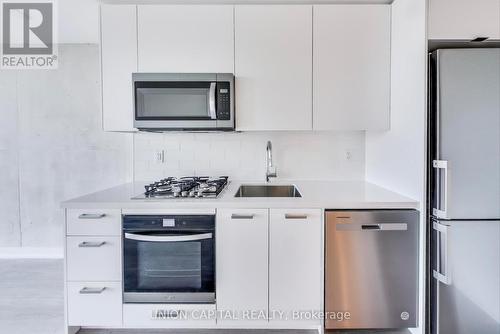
<box><xmin>366</xmin><ymin>0</ymin><xmax>427</xmax><ymax>333</ymax></box>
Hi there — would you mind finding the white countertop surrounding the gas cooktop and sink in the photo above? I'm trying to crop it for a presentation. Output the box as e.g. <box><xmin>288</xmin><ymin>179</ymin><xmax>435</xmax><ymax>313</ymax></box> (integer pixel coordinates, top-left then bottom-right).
<box><xmin>61</xmin><ymin>180</ymin><xmax>419</xmax><ymax>209</ymax></box>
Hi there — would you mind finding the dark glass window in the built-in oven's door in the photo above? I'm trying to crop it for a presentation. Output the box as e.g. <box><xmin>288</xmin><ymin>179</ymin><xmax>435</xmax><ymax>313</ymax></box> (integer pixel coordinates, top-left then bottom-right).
<box><xmin>137</xmin><ymin>242</ymin><xmax>202</xmax><ymax>290</ymax></box>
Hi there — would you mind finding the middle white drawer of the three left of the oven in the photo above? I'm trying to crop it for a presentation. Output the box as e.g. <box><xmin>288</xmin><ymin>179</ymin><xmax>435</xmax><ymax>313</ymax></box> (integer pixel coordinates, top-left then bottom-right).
<box><xmin>66</xmin><ymin>236</ymin><xmax>121</xmax><ymax>281</ymax></box>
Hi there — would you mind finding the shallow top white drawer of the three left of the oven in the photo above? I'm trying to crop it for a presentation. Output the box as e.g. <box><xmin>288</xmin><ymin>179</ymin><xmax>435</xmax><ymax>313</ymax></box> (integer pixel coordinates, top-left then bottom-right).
<box><xmin>66</xmin><ymin>209</ymin><xmax>121</xmax><ymax>236</ymax></box>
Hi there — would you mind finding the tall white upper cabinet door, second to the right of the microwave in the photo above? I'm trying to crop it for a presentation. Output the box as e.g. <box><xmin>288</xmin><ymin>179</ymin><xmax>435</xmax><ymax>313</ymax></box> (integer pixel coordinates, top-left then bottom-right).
<box><xmin>313</xmin><ymin>5</ymin><xmax>391</xmax><ymax>130</ymax></box>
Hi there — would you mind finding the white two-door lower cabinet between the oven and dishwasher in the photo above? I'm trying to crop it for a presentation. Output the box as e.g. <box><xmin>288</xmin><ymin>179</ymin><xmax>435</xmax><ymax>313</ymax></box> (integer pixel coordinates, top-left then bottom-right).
<box><xmin>216</xmin><ymin>209</ymin><xmax>323</xmax><ymax>328</ymax></box>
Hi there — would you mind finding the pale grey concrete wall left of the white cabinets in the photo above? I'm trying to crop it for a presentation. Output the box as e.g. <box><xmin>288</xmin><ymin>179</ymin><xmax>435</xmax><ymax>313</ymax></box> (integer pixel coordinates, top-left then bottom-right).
<box><xmin>0</xmin><ymin>45</ymin><xmax>132</xmax><ymax>252</ymax></box>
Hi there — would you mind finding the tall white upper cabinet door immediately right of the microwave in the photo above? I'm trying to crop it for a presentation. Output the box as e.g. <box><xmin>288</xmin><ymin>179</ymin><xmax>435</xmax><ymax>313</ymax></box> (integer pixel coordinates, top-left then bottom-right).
<box><xmin>235</xmin><ymin>5</ymin><xmax>312</xmax><ymax>130</ymax></box>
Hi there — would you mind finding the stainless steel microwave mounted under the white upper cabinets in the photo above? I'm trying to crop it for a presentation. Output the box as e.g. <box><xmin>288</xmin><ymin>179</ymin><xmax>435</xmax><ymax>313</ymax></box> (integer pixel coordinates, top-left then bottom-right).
<box><xmin>132</xmin><ymin>73</ymin><xmax>234</xmax><ymax>131</ymax></box>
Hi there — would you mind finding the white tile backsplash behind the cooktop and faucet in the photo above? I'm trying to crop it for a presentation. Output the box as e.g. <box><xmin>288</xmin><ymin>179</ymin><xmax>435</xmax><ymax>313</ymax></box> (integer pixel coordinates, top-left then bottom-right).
<box><xmin>134</xmin><ymin>131</ymin><xmax>365</xmax><ymax>181</ymax></box>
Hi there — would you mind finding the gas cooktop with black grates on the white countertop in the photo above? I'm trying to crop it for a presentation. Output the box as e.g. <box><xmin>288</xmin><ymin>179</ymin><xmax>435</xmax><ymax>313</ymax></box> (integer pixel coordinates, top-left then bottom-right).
<box><xmin>132</xmin><ymin>176</ymin><xmax>228</xmax><ymax>199</ymax></box>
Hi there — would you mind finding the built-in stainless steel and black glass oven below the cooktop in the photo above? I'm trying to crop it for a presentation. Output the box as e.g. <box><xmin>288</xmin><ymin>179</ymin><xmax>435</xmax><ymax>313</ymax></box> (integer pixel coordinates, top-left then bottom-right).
<box><xmin>123</xmin><ymin>215</ymin><xmax>215</xmax><ymax>304</ymax></box>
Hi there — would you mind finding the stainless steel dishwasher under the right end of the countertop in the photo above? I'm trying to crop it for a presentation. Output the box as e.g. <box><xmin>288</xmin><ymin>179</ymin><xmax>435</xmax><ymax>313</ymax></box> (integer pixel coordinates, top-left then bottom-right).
<box><xmin>325</xmin><ymin>210</ymin><xmax>419</xmax><ymax>329</ymax></box>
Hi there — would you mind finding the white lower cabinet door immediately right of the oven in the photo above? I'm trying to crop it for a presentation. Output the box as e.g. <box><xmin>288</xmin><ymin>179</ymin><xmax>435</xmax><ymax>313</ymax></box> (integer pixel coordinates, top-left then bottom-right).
<box><xmin>216</xmin><ymin>209</ymin><xmax>268</xmax><ymax>327</ymax></box>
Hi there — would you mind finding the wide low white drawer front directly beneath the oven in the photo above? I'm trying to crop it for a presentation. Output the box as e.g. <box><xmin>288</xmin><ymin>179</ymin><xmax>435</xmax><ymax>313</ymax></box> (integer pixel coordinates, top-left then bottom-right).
<box><xmin>123</xmin><ymin>304</ymin><xmax>216</xmax><ymax>328</ymax></box>
